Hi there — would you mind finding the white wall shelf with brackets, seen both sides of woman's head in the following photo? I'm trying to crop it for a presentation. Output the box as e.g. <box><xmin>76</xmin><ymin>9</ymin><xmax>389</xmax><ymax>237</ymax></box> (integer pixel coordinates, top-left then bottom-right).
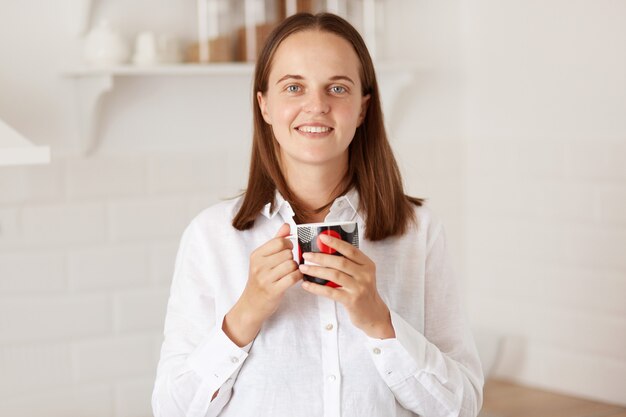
<box><xmin>63</xmin><ymin>62</ymin><xmax>423</xmax><ymax>155</ymax></box>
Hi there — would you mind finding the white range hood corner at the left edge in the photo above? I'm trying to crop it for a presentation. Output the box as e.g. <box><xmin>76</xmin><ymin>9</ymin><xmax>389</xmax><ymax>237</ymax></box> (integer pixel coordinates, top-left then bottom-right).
<box><xmin>0</xmin><ymin>119</ymin><xmax>50</xmax><ymax>166</ymax></box>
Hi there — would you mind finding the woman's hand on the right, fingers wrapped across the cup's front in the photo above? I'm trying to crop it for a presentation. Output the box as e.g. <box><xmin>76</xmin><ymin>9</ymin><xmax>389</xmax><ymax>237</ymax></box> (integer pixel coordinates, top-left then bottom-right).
<box><xmin>300</xmin><ymin>235</ymin><xmax>395</xmax><ymax>339</ymax></box>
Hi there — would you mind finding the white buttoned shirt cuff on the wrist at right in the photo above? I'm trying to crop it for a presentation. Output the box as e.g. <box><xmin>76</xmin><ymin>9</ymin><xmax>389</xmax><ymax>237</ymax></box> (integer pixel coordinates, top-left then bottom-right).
<box><xmin>365</xmin><ymin>311</ymin><xmax>426</xmax><ymax>387</ymax></box>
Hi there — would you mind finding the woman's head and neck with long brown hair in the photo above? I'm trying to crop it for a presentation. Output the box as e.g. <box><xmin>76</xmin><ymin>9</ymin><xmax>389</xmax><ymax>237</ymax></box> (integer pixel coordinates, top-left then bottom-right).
<box><xmin>233</xmin><ymin>14</ymin><xmax>422</xmax><ymax>234</ymax></box>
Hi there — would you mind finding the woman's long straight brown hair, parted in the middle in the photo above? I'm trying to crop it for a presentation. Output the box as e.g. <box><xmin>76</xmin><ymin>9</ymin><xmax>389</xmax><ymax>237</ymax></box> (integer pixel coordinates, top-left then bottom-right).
<box><xmin>233</xmin><ymin>13</ymin><xmax>423</xmax><ymax>241</ymax></box>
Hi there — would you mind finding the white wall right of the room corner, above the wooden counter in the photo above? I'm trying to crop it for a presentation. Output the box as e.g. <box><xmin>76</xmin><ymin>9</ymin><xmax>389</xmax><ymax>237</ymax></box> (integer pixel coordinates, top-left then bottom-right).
<box><xmin>464</xmin><ymin>0</ymin><xmax>626</xmax><ymax>405</ymax></box>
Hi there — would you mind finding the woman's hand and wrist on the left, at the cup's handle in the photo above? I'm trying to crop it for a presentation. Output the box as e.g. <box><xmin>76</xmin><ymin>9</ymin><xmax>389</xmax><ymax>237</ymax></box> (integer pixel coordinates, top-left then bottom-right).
<box><xmin>222</xmin><ymin>223</ymin><xmax>302</xmax><ymax>347</ymax></box>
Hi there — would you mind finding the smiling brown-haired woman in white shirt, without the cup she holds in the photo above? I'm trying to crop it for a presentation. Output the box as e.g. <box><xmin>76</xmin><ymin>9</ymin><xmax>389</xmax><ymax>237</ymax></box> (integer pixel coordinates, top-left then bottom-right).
<box><xmin>153</xmin><ymin>14</ymin><xmax>483</xmax><ymax>417</ymax></box>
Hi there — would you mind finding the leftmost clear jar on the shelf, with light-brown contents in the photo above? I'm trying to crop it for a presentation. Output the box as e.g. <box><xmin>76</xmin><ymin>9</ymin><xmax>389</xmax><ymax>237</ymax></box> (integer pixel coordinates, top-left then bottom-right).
<box><xmin>187</xmin><ymin>0</ymin><xmax>235</xmax><ymax>63</ymax></box>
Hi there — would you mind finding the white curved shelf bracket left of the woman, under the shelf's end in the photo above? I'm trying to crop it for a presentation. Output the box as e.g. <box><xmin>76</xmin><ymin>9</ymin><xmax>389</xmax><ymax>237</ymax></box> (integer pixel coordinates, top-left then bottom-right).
<box><xmin>76</xmin><ymin>74</ymin><xmax>113</xmax><ymax>155</ymax></box>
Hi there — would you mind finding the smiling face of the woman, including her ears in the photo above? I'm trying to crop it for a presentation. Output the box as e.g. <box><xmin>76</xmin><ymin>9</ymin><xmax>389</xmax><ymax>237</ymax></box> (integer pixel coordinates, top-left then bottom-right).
<box><xmin>257</xmin><ymin>30</ymin><xmax>369</xmax><ymax>169</ymax></box>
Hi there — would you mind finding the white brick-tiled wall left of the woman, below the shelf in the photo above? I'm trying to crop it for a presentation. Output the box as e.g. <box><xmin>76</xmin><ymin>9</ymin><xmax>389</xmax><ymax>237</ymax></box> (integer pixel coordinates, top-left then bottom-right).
<box><xmin>0</xmin><ymin>153</ymin><xmax>217</xmax><ymax>417</ymax></box>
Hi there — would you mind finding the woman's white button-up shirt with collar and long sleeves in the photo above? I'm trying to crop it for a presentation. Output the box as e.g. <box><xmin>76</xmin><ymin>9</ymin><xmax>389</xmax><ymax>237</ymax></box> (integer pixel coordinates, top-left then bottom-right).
<box><xmin>152</xmin><ymin>190</ymin><xmax>483</xmax><ymax>417</ymax></box>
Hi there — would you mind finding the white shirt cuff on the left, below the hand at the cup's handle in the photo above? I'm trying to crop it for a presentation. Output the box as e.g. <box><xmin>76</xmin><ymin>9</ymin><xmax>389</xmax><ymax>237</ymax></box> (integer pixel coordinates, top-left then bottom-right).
<box><xmin>187</xmin><ymin>318</ymin><xmax>252</xmax><ymax>387</ymax></box>
